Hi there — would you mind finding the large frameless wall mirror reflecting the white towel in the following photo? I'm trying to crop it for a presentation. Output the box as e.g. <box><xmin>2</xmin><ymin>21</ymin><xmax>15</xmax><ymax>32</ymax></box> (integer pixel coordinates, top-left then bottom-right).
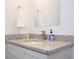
<box><xmin>34</xmin><ymin>0</ymin><xmax>60</xmax><ymax>27</ymax></box>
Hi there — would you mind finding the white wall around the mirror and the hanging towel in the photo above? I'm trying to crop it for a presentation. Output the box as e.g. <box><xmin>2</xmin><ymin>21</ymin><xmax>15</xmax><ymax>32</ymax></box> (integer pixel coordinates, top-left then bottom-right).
<box><xmin>5</xmin><ymin>0</ymin><xmax>74</xmax><ymax>35</ymax></box>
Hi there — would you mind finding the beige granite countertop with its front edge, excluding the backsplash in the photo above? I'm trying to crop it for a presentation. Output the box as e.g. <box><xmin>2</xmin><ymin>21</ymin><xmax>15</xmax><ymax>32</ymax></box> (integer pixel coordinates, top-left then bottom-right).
<box><xmin>6</xmin><ymin>39</ymin><xmax>73</xmax><ymax>55</ymax></box>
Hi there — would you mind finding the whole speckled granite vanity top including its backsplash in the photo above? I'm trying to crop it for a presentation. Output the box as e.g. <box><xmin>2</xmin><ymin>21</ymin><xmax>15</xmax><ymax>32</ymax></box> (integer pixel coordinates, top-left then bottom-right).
<box><xmin>6</xmin><ymin>34</ymin><xmax>74</xmax><ymax>54</ymax></box>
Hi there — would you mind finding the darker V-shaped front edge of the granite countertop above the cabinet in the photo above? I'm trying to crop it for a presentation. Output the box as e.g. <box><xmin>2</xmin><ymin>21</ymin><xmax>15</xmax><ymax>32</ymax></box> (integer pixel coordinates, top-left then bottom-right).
<box><xmin>5</xmin><ymin>40</ymin><xmax>74</xmax><ymax>55</ymax></box>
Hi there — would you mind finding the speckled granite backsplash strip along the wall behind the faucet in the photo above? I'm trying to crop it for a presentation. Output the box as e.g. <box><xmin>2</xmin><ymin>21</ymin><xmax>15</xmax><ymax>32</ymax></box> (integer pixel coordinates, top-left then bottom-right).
<box><xmin>5</xmin><ymin>34</ymin><xmax>74</xmax><ymax>42</ymax></box>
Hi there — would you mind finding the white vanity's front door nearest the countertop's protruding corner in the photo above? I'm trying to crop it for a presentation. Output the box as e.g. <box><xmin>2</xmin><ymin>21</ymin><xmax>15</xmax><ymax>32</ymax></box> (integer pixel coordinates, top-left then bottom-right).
<box><xmin>23</xmin><ymin>49</ymin><xmax>48</xmax><ymax>59</ymax></box>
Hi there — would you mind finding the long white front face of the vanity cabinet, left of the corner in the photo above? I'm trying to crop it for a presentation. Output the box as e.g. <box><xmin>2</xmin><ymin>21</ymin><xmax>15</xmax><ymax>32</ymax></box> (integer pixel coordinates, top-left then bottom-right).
<box><xmin>7</xmin><ymin>44</ymin><xmax>47</xmax><ymax>59</ymax></box>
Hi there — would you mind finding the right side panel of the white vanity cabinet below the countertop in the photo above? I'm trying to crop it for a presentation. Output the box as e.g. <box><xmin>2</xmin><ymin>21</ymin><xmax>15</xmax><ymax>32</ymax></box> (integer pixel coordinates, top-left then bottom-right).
<box><xmin>49</xmin><ymin>47</ymin><xmax>71</xmax><ymax>59</ymax></box>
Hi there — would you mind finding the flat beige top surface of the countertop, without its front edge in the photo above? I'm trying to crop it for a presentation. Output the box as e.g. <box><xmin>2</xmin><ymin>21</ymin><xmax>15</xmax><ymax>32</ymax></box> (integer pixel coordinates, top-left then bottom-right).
<box><xmin>7</xmin><ymin>40</ymin><xmax>70</xmax><ymax>51</ymax></box>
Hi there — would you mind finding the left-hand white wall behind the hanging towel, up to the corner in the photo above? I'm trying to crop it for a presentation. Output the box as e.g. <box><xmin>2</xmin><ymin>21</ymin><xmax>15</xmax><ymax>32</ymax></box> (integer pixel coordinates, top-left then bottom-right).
<box><xmin>5</xmin><ymin>0</ymin><xmax>29</xmax><ymax>34</ymax></box>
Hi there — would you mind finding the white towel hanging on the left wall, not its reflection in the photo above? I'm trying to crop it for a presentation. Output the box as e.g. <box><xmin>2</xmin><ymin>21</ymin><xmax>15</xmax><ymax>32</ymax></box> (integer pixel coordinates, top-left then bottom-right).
<box><xmin>17</xmin><ymin>6</ymin><xmax>25</xmax><ymax>28</ymax></box>
